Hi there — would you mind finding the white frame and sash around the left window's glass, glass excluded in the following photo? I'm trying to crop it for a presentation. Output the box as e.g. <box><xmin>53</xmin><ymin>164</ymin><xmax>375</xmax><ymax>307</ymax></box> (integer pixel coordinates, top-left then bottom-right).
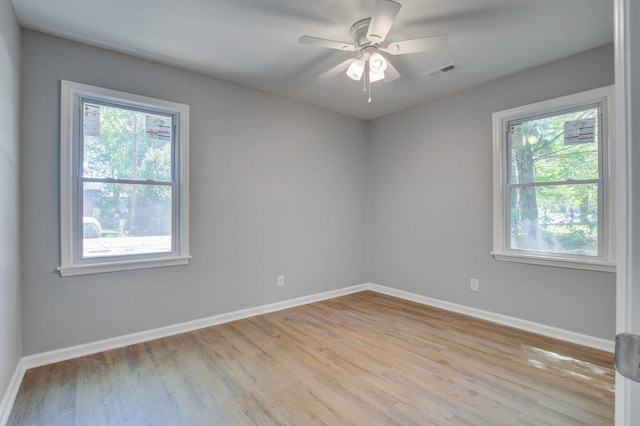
<box><xmin>57</xmin><ymin>80</ymin><xmax>191</xmax><ymax>277</ymax></box>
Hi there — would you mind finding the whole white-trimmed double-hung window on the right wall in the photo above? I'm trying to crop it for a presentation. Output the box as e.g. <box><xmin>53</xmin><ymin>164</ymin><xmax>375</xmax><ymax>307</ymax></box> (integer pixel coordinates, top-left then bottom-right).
<box><xmin>492</xmin><ymin>86</ymin><xmax>615</xmax><ymax>271</ymax></box>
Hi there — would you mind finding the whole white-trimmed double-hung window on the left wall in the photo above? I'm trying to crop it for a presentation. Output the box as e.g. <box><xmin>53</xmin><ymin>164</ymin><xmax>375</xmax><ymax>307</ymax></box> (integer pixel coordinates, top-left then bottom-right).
<box><xmin>58</xmin><ymin>81</ymin><xmax>189</xmax><ymax>276</ymax></box>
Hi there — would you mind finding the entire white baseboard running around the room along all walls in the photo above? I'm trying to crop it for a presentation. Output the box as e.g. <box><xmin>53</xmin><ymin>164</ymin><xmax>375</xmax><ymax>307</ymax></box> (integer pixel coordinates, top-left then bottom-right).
<box><xmin>0</xmin><ymin>283</ymin><xmax>615</xmax><ymax>425</ymax></box>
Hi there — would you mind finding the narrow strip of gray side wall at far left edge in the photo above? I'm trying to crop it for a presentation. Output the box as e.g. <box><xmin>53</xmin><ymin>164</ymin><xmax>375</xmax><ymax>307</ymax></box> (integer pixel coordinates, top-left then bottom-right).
<box><xmin>0</xmin><ymin>0</ymin><xmax>22</xmax><ymax>398</ymax></box>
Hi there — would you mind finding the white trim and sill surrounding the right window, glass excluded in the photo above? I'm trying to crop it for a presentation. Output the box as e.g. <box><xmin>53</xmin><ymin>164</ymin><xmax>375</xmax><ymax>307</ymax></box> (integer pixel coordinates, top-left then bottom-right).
<box><xmin>491</xmin><ymin>85</ymin><xmax>616</xmax><ymax>272</ymax></box>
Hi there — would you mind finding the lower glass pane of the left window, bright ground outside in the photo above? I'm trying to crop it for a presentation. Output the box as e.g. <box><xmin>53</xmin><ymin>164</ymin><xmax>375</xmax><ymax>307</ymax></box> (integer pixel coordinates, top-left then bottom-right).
<box><xmin>82</xmin><ymin>182</ymin><xmax>173</xmax><ymax>257</ymax></box>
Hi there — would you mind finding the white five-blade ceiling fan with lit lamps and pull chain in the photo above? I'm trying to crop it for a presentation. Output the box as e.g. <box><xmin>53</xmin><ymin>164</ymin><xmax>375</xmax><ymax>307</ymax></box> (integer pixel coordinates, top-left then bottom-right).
<box><xmin>298</xmin><ymin>0</ymin><xmax>448</xmax><ymax>102</ymax></box>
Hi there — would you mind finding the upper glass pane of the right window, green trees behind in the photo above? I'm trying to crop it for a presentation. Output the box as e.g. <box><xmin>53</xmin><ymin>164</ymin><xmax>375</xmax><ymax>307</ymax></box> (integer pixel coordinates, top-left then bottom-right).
<box><xmin>509</xmin><ymin>107</ymin><xmax>599</xmax><ymax>183</ymax></box>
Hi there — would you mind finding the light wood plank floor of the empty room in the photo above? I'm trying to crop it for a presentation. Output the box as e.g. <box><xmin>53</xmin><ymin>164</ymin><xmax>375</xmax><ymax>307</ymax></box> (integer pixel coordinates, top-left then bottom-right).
<box><xmin>8</xmin><ymin>292</ymin><xmax>614</xmax><ymax>425</ymax></box>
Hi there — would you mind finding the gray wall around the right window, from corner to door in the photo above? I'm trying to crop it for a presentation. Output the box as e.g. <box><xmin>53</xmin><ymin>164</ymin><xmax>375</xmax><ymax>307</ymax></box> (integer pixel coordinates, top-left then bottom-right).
<box><xmin>368</xmin><ymin>45</ymin><xmax>615</xmax><ymax>339</ymax></box>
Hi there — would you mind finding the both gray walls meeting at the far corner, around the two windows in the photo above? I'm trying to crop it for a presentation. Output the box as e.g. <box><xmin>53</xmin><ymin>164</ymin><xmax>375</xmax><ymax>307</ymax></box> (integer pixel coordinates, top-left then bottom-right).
<box><xmin>21</xmin><ymin>30</ymin><xmax>615</xmax><ymax>354</ymax></box>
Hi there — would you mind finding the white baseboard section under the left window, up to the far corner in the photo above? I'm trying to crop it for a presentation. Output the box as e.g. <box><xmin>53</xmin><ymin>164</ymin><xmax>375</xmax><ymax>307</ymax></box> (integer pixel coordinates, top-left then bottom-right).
<box><xmin>22</xmin><ymin>284</ymin><xmax>367</xmax><ymax>369</ymax></box>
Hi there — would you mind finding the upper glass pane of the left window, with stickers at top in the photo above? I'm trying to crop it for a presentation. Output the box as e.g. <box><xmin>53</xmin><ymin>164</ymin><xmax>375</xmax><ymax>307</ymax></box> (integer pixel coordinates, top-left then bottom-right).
<box><xmin>82</xmin><ymin>102</ymin><xmax>173</xmax><ymax>182</ymax></box>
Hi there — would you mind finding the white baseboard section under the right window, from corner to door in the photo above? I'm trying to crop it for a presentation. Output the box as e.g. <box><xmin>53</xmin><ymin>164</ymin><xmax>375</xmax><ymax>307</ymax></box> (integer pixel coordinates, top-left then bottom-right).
<box><xmin>366</xmin><ymin>283</ymin><xmax>615</xmax><ymax>353</ymax></box>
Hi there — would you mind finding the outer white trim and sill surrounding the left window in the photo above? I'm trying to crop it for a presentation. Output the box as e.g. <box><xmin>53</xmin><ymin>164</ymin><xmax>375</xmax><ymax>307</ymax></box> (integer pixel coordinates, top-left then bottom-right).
<box><xmin>57</xmin><ymin>80</ymin><xmax>191</xmax><ymax>277</ymax></box>
